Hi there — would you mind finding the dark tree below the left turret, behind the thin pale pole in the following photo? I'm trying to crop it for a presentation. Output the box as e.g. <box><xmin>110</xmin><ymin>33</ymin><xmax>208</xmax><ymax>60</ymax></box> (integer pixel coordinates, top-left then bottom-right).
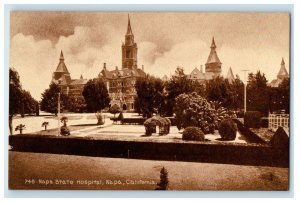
<box><xmin>40</xmin><ymin>82</ymin><xmax>69</xmax><ymax>116</ymax></box>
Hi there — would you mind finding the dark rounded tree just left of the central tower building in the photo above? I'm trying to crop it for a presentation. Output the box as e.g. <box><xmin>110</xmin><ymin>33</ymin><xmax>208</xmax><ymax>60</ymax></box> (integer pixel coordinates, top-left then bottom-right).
<box><xmin>82</xmin><ymin>78</ymin><xmax>110</xmax><ymax>123</ymax></box>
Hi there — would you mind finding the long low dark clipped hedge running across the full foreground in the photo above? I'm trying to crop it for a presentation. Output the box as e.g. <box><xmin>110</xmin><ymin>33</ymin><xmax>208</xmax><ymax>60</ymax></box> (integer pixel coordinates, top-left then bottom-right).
<box><xmin>9</xmin><ymin>135</ymin><xmax>289</xmax><ymax>167</ymax></box>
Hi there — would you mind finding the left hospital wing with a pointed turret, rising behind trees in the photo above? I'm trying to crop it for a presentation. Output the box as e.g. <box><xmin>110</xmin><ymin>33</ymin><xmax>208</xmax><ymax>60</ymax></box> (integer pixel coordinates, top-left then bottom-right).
<box><xmin>52</xmin><ymin>51</ymin><xmax>87</xmax><ymax>101</ymax></box>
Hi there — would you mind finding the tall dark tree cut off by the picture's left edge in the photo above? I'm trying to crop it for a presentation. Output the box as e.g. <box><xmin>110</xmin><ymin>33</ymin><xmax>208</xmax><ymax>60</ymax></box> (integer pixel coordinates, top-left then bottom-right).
<box><xmin>9</xmin><ymin>68</ymin><xmax>22</xmax><ymax>135</ymax></box>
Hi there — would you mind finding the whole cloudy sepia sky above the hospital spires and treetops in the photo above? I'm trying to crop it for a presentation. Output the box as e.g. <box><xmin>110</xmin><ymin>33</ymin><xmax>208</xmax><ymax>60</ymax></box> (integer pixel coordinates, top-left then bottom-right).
<box><xmin>10</xmin><ymin>12</ymin><xmax>290</xmax><ymax>100</ymax></box>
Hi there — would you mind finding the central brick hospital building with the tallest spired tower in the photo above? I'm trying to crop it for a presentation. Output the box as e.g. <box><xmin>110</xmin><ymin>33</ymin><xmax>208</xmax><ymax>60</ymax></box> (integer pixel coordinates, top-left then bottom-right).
<box><xmin>99</xmin><ymin>16</ymin><xmax>146</xmax><ymax>111</ymax></box>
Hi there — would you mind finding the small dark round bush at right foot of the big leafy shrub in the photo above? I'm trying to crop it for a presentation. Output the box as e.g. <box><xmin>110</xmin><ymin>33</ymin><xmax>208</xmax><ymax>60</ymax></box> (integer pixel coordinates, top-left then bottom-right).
<box><xmin>219</xmin><ymin>119</ymin><xmax>237</xmax><ymax>140</ymax></box>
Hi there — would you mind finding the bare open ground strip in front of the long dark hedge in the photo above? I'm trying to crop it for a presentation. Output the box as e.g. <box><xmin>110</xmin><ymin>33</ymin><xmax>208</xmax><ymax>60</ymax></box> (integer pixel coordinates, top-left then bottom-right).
<box><xmin>9</xmin><ymin>151</ymin><xmax>288</xmax><ymax>190</ymax></box>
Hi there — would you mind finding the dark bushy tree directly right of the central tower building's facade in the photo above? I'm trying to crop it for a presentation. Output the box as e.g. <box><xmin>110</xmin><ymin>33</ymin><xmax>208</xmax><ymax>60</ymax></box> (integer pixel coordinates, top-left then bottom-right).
<box><xmin>135</xmin><ymin>75</ymin><xmax>164</xmax><ymax>117</ymax></box>
